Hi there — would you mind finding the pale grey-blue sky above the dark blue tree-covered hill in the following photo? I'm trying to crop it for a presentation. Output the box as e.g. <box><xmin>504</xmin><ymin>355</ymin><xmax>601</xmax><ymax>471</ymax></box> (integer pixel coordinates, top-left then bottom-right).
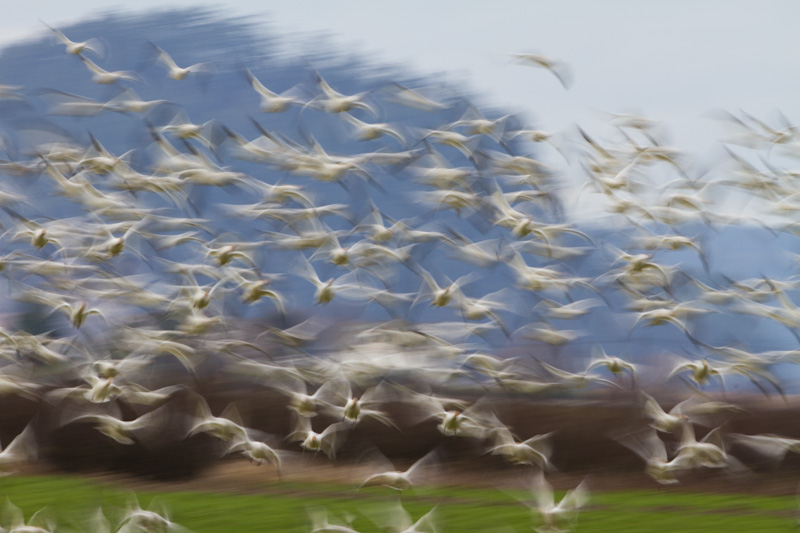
<box><xmin>0</xmin><ymin>0</ymin><xmax>800</xmax><ymax>216</ymax></box>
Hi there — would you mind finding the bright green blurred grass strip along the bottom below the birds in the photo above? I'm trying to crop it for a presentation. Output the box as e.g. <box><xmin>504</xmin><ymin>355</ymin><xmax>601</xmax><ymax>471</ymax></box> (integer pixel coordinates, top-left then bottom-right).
<box><xmin>0</xmin><ymin>476</ymin><xmax>797</xmax><ymax>533</ymax></box>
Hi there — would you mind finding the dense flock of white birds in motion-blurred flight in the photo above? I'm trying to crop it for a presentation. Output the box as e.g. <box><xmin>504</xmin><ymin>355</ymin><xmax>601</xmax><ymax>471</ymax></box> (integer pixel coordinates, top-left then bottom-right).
<box><xmin>0</xmin><ymin>18</ymin><xmax>800</xmax><ymax>533</ymax></box>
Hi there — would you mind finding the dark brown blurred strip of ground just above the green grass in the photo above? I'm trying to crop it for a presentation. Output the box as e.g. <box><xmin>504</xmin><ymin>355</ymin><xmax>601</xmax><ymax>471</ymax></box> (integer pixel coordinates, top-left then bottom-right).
<box><xmin>31</xmin><ymin>395</ymin><xmax>800</xmax><ymax>497</ymax></box>
